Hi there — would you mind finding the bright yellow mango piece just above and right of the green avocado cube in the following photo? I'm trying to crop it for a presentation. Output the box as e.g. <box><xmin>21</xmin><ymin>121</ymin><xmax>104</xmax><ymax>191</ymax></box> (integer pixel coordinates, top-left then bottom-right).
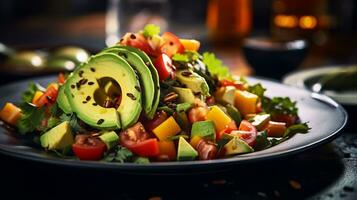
<box><xmin>206</xmin><ymin>106</ymin><xmax>232</xmax><ymax>132</ymax></box>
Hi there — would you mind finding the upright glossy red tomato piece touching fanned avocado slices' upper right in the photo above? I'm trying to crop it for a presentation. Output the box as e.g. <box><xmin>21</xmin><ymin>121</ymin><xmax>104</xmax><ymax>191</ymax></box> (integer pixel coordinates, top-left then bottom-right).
<box><xmin>154</xmin><ymin>53</ymin><xmax>175</xmax><ymax>81</ymax></box>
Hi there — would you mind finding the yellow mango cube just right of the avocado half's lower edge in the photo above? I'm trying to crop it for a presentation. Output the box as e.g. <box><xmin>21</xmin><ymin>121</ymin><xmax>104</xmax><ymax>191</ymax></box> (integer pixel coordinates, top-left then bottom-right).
<box><xmin>152</xmin><ymin>116</ymin><xmax>181</xmax><ymax>140</ymax></box>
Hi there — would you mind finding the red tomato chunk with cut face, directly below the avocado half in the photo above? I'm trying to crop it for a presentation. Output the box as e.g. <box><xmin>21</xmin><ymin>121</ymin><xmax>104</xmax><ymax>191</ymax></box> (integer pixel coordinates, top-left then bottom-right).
<box><xmin>120</xmin><ymin>122</ymin><xmax>160</xmax><ymax>157</ymax></box>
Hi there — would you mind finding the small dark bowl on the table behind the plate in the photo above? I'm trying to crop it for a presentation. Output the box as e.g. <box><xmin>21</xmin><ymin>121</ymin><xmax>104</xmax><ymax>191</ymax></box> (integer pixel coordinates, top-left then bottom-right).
<box><xmin>243</xmin><ymin>37</ymin><xmax>308</xmax><ymax>79</ymax></box>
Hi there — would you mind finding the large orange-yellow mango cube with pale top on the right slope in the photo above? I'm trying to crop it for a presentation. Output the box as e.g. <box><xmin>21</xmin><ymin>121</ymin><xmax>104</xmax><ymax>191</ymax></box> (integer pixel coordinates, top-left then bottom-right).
<box><xmin>234</xmin><ymin>90</ymin><xmax>258</xmax><ymax>116</ymax></box>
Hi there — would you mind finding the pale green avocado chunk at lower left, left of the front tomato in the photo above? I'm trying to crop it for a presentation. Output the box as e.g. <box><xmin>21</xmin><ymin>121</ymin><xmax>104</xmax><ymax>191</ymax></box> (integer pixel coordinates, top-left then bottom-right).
<box><xmin>40</xmin><ymin>121</ymin><xmax>74</xmax><ymax>150</ymax></box>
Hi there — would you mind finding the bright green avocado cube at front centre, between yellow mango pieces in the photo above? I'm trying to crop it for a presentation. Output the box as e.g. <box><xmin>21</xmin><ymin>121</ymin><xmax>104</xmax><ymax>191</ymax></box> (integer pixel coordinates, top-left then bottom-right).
<box><xmin>191</xmin><ymin>120</ymin><xmax>216</xmax><ymax>141</ymax></box>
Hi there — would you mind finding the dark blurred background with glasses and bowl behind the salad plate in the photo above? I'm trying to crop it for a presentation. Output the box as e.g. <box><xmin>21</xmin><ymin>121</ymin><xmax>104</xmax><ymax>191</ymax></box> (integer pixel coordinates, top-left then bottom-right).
<box><xmin>0</xmin><ymin>0</ymin><xmax>357</xmax><ymax>83</ymax></box>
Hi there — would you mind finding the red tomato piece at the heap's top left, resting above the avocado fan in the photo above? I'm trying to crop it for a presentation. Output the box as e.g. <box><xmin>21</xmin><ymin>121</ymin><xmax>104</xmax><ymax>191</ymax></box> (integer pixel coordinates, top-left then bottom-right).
<box><xmin>120</xmin><ymin>33</ymin><xmax>157</xmax><ymax>56</ymax></box>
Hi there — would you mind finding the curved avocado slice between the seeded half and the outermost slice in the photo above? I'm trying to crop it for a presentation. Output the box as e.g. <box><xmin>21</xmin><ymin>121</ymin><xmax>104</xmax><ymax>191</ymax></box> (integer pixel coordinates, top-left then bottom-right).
<box><xmin>100</xmin><ymin>48</ymin><xmax>155</xmax><ymax>116</ymax></box>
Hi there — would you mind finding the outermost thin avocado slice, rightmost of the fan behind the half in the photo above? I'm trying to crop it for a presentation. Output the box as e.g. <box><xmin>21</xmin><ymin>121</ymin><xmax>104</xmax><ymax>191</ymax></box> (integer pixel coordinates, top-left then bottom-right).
<box><xmin>102</xmin><ymin>46</ymin><xmax>160</xmax><ymax>119</ymax></box>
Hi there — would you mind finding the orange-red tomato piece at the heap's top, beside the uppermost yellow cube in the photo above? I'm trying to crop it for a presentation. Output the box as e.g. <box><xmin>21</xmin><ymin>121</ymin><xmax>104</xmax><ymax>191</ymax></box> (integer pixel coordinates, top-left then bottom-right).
<box><xmin>160</xmin><ymin>32</ymin><xmax>185</xmax><ymax>58</ymax></box>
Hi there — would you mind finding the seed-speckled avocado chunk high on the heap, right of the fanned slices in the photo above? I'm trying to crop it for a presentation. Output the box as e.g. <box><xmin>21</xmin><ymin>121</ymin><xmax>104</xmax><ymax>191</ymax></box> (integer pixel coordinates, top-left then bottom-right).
<box><xmin>175</xmin><ymin>69</ymin><xmax>210</xmax><ymax>96</ymax></box>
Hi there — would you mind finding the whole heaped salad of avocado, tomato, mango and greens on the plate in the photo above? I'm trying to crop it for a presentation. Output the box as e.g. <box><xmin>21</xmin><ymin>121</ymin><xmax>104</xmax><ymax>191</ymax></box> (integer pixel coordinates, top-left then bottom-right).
<box><xmin>0</xmin><ymin>24</ymin><xmax>309</xmax><ymax>163</ymax></box>
